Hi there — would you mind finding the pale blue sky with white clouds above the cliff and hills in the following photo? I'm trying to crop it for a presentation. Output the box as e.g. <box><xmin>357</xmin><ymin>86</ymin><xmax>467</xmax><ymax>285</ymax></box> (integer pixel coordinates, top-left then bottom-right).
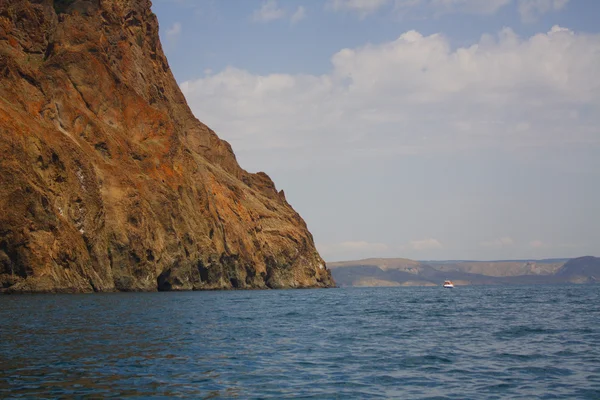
<box><xmin>153</xmin><ymin>0</ymin><xmax>600</xmax><ymax>262</ymax></box>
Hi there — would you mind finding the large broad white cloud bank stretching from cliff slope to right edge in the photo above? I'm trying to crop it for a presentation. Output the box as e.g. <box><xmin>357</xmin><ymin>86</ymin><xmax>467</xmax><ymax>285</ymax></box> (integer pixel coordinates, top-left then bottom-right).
<box><xmin>181</xmin><ymin>27</ymin><xmax>600</xmax><ymax>170</ymax></box>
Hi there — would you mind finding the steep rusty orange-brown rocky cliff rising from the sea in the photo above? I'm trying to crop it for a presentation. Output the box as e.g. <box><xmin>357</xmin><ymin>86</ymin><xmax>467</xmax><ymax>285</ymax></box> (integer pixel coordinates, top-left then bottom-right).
<box><xmin>0</xmin><ymin>0</ymin><xmax>334</xmax><ymax>292</ymax></box>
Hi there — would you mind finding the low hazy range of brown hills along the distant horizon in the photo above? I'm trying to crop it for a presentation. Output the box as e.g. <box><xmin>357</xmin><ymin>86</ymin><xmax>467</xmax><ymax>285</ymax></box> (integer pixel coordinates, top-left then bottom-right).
<box><xmin>328</xmin><ymin>257</ymin><xmax>600</xmax><ymax>286</ymax></box>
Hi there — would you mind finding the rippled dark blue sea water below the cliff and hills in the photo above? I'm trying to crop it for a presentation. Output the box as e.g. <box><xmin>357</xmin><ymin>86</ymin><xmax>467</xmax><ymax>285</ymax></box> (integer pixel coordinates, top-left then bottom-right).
<box><xmin>0</xmin><ymin>286</ymin><xmax>600</xmax><ymax>399</ymax></box>
